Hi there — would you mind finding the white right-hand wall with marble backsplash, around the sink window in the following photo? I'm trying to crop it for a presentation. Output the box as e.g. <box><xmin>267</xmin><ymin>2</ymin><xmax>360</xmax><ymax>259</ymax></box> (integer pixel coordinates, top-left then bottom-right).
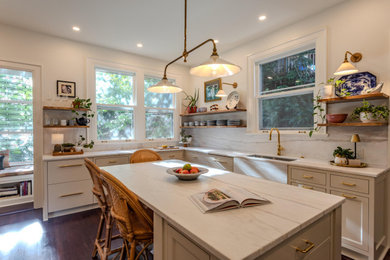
<box><xmin>188</xmin><ymin>0</ymin><xmax>390</xmax><ymax>167</ymax></box>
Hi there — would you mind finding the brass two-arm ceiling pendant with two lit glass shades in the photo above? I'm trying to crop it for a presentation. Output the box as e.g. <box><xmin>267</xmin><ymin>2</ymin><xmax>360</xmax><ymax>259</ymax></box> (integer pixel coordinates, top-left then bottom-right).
<box><xmin>148</xmin><ymin>0</ymin><xmax>241</xmax><ymax>93</ymax></box>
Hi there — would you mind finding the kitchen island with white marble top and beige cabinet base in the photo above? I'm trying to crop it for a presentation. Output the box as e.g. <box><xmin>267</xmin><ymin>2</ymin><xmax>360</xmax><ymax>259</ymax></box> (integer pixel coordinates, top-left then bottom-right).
<box><xmin>103</xmin><ymin>160</ymin><xmax>344</xmax><ymax>260</ymax></box>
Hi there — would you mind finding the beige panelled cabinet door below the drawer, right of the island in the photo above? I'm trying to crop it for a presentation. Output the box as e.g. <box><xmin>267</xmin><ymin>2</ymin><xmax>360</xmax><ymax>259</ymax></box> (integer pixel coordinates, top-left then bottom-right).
<box><xmin>331</xmin><ymin>190</ymin><xmax>368</xmax><ymax>250</ymax></box>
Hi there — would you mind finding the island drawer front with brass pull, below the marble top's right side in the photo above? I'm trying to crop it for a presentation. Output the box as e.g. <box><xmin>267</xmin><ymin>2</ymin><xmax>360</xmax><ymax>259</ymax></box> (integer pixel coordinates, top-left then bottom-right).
<box><xmin>260</xmin><ymin>214</ymin><xmax>331</xmax><ymax>260</ymax></box>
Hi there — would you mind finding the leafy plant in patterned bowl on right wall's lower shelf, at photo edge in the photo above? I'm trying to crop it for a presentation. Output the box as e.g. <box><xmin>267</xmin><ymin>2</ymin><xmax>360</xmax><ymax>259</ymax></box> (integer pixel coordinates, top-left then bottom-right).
<box><xmin>351</xmin><ymin>100</ymin><xmax>389</xmax><ymax>123</ymax></box>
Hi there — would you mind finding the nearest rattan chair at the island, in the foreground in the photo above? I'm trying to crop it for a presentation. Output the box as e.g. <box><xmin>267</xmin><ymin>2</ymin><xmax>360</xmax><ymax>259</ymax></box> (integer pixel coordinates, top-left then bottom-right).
<box><xmin>100</xmin><ymin>170</ymin><xmax>153</xmax><ymax>260</ymax></box>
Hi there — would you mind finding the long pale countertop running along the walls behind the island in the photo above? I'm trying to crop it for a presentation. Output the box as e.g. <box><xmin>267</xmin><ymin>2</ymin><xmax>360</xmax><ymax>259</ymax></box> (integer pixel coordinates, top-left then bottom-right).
<box><xmin>43</xmin><ymin>147</ymin><xmax>390</xmax><ymax>177</ymax></box>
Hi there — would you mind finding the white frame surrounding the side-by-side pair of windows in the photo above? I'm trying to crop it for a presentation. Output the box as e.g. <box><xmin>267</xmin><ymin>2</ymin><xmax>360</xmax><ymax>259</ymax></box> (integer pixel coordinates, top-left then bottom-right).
<box><xmin>87</xmin><ymin>58</ymin><xmax>184</xmax><ymax>146</ymax></box>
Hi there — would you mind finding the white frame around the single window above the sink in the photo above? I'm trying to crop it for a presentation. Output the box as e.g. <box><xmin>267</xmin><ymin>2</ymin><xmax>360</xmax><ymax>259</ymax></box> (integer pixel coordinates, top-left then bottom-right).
<box><xmin>247</xmin><ymin>29</ymin><xmax>327</xmax><ymax>134</ymax></box>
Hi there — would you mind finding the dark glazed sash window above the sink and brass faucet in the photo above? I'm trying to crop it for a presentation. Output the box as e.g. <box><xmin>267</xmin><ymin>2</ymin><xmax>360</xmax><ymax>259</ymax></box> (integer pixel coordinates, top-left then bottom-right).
<box><xmin>256</xmin><ymin>48</ymin><xmax>316</xmax><ymax>129</ymax></box>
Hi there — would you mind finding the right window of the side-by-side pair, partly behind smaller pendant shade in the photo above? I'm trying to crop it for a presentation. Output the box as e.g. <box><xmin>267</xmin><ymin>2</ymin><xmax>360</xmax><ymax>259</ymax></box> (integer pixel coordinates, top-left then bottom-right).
<box><xmin>144</xmin><ymin>76</ymin><xmax>175</xmax><ymax>139</ymax></box>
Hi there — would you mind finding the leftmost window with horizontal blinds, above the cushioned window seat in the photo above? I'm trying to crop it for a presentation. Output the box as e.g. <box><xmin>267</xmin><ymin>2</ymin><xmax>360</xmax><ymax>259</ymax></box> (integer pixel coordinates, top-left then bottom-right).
<box><xmin>0</xmin><ymin>68</ymin><xmax>33</xmax><ymax>164</ymax></box>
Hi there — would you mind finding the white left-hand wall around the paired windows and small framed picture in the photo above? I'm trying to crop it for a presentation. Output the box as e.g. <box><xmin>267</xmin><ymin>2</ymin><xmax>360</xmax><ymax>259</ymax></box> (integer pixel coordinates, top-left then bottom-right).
<box><xmin>0</xmin><ymin>24</ymin><xmax>189</xmax><ymax>207</ymax></box>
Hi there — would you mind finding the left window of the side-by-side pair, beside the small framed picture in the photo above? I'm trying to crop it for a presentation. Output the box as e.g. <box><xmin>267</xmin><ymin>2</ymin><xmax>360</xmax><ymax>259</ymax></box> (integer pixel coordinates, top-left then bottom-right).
<box><xmin>95</xmin><ymin>68</ymin><xmax>135</xmax><ymax>141</ymax></box>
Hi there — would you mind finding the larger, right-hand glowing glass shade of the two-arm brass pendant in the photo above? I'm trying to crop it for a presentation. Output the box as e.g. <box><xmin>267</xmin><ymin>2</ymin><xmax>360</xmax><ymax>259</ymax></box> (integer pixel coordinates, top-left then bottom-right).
<box><xmin>190</xmin><ymin>55</ymin><xmax>241</xmax><ymax>77</ymax></box>
